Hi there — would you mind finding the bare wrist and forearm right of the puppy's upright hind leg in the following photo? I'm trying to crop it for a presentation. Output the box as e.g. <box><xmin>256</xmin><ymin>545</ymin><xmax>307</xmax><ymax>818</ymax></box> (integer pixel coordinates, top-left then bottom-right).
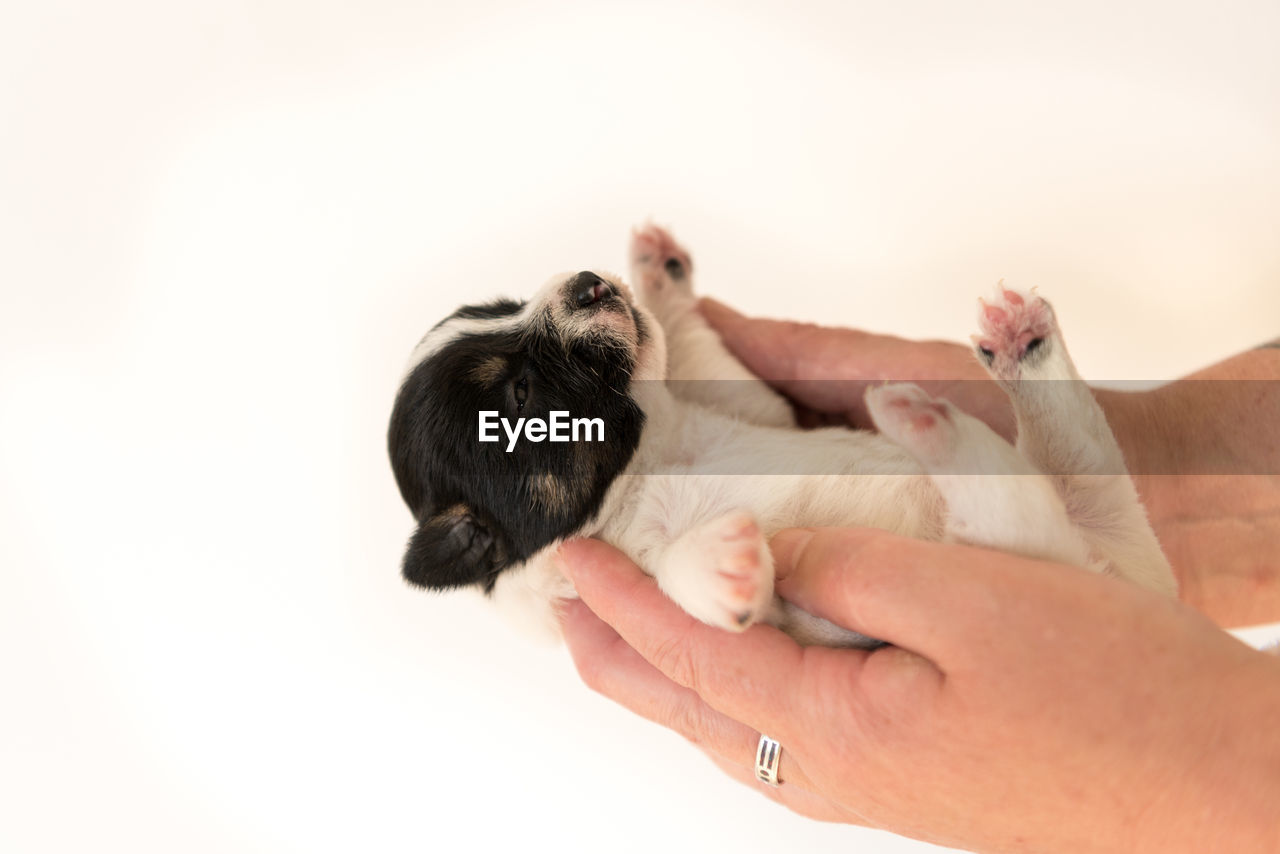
<box><xmin>1096</xmin><ymin>348</ymin><xmax>1280</xmax><ymax>626</ymax></box>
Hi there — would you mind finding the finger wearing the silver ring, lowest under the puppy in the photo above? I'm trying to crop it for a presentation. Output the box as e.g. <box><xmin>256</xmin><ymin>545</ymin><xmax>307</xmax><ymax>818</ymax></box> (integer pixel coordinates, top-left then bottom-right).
<box><xmin>562</xmin><ymin>600</ymin><xmax>813</xmax><ymax>789</ymax></box>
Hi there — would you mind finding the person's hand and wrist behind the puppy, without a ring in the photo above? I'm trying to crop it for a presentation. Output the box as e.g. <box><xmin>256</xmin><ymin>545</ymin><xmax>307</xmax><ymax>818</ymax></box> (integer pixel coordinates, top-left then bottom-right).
<box><xmin>699</xmin><ymin>300</ymin><xmax>1280</xmax><ymax>626</ymax></box>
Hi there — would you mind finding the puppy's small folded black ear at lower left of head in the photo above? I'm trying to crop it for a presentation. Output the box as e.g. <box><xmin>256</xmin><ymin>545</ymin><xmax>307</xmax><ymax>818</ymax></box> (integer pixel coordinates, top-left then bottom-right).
<box><xmin>403</xmin><ymin>504</ymin><xmax>507</xmax><ymax>590</ymax></box>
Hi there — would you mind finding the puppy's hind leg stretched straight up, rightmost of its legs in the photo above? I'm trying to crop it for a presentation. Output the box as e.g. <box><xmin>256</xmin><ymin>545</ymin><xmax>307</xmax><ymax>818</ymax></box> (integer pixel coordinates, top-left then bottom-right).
<box><xmin>974</xmin><ymin>286</ymin><xmax>1178</xmax><ymax>594</ymax></box>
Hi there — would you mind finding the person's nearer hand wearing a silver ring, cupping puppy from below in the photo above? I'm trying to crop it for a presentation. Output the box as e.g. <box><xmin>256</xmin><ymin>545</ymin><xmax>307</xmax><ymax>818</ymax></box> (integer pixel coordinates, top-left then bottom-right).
<box><xmin>558</xmin><ymin>529</ymin><xmax>1280</xmax><ymax>851</ymax></box>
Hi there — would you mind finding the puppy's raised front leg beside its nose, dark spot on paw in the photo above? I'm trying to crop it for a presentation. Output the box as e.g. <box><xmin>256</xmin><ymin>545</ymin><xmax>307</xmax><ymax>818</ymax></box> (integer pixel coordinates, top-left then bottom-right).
<box><xmin>630</xmin><ymin>224</ymin><xmax>795</xmax><ymax>426</ymax></box>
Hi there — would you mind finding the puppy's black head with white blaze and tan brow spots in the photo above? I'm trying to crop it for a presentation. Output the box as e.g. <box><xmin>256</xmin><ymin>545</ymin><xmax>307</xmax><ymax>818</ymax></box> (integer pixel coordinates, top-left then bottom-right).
<box><xmin>388</xmin><ymin>271</ymin><xmax>662</xmax><ymax>592</ymax></box>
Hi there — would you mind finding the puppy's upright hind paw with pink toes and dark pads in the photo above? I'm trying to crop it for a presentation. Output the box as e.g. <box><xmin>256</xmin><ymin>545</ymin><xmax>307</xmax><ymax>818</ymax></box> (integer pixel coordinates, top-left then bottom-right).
<box><xmin>973</xmin><ymin>284</ymin><xmax>1059</xmax><ymax>380</ymax></box>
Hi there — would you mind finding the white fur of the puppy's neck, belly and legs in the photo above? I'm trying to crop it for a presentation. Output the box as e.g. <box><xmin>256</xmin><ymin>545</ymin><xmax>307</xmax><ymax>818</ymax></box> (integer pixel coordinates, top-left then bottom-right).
<box><xmin>483</xmin><ymin>227</ymin><xmax>1175</xmax><ymax>644</ymax></box>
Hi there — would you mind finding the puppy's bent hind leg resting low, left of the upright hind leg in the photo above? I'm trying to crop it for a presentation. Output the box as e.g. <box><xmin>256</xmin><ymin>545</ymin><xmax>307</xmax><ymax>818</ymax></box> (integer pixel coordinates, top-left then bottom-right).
<box><xmin>867</xmin><ymin>384</ymin><xmax>1097</xmax><ymax>568</ymax></box>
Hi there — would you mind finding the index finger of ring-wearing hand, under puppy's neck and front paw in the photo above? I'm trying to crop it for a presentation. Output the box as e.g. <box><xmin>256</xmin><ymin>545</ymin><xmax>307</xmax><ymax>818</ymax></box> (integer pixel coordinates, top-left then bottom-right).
<box><xmin>557</xmin><ymin>539</ymin><xmax>829</xmax><ymax>741</ymax></box>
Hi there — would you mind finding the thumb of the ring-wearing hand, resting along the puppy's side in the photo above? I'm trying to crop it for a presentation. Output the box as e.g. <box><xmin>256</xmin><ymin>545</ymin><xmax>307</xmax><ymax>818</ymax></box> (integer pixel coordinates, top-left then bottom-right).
<box><xmin>769</xmin><ymin>528</ymin><xmax>1053</xmax><ymax>671</ymax></box>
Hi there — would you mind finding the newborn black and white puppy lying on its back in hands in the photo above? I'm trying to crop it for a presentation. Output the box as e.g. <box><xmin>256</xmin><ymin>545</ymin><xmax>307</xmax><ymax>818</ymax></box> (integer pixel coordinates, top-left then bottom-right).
<box><xmin>388</xmin><ymin>225</ymin><xmax>1176</xmax><ymax>645</ymax></box>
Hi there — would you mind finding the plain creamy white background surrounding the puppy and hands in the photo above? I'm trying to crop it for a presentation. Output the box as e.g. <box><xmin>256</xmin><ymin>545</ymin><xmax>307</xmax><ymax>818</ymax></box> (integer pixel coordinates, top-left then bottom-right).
<box><xmin>0</xmin><ymin>0</ymin><xmax>1280</xmax><ymax>853</ymax></box>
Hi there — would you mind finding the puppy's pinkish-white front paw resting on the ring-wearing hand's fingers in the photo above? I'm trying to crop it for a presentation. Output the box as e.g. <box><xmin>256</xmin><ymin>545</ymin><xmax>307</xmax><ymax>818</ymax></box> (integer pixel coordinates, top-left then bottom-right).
<box><xmin>658</xmin><ymin>512</ymin><xmax>773</xmax><ymax>631</ymax></box>
